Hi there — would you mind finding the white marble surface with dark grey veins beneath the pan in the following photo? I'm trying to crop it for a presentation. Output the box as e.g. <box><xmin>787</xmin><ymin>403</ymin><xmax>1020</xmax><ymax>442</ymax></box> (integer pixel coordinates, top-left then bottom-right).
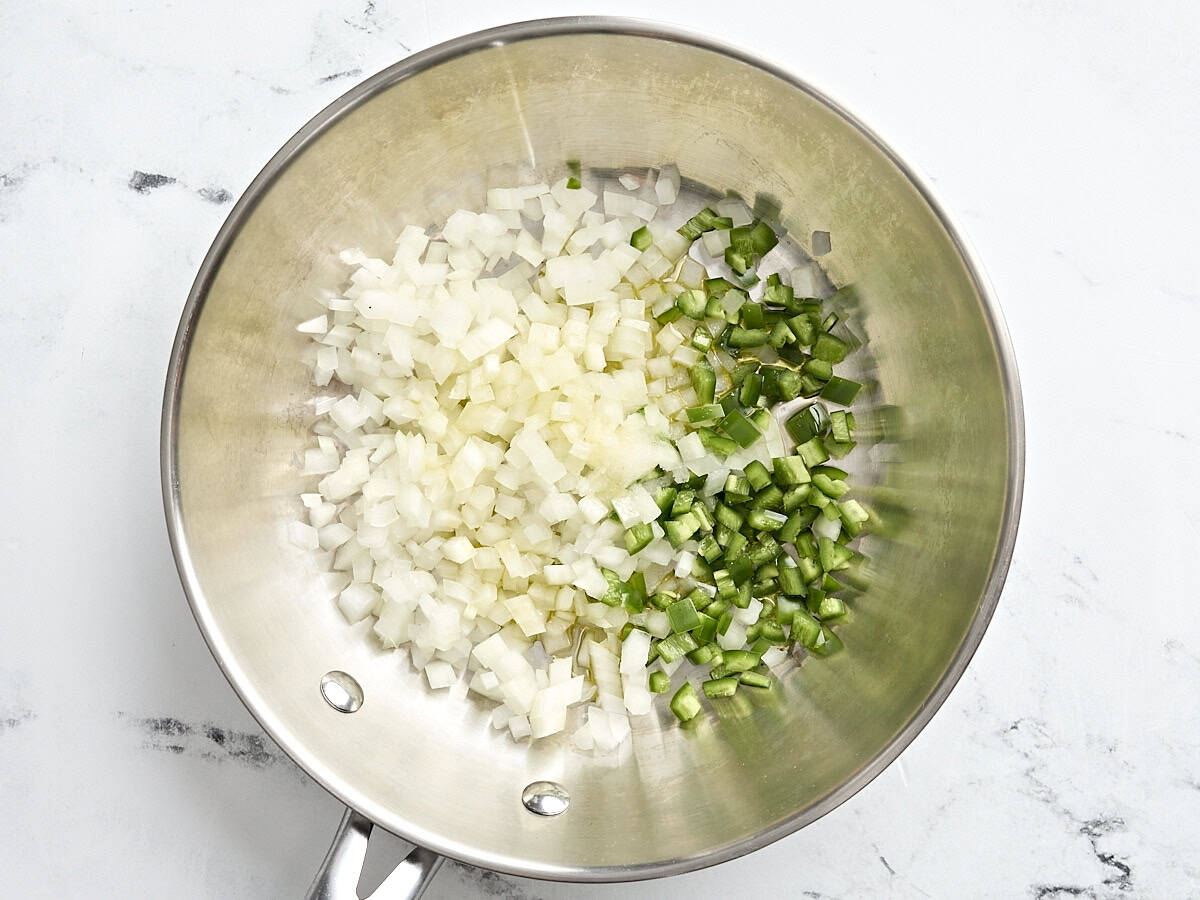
<box><xmin>0</xmin><ymin>0</ymin><xmax>1200</xmax><ymax>900</ymax></box>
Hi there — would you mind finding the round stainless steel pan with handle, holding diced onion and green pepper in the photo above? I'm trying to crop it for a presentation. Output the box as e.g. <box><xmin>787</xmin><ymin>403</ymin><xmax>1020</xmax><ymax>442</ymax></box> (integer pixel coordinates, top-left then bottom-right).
<box><xmin>162</xmin><ymin>18</ymin><xmax>1024</xmax><ymax>896</ymax></box>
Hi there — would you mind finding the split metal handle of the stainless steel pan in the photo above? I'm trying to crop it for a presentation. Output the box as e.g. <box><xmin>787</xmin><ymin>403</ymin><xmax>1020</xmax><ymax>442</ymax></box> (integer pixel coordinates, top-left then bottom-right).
<box><xmin>305</xmin><ymin>809</ymin><xmax>444</xmax><ymax>900</ymax></box>
